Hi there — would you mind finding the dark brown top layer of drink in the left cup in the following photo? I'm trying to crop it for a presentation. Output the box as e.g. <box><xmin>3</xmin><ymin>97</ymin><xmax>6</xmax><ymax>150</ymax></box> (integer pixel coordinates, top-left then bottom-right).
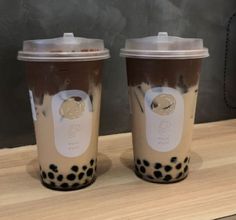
<box><xmin>26</xmin><ymin>60</ymin><xmax>103</xmax><ymax>104</ymax></box>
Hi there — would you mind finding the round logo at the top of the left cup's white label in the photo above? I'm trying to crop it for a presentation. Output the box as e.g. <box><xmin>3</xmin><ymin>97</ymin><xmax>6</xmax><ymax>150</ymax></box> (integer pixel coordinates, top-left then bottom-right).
<box><xmin>59</xmin><ymin>98</ymin><xmax>85</xmax><ymax>119</ymax></box>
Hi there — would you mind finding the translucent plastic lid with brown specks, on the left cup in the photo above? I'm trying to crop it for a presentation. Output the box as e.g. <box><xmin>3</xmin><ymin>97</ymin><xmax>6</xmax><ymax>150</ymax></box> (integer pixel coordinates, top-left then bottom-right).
<box><xmin>17</xmin><ymin>33</ymin><xmax>110</xmax><ymax>62</ymax></box>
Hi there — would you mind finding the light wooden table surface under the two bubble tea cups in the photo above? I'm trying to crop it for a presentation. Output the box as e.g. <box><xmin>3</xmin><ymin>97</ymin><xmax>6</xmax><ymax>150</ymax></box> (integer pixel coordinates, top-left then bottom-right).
<box><xmin>0</xmin><ymin>120</ymin><xmax>236</xmax><ymax>220</ymax></box>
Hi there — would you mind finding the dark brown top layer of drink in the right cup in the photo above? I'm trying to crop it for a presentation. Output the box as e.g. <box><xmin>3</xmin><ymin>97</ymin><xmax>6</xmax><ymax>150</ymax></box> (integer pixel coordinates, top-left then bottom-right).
<box><xmin>126</xmin><ymin>58</ymin><xmax>202</xmax><ymax>90</ymax></box>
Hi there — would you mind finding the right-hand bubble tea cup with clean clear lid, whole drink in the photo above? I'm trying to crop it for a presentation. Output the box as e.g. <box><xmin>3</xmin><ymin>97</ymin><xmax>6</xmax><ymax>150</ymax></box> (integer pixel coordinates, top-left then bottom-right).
<box><xmin>121</xmin><ymin>33</ymin><xmax>208</xmax><ymax>183</ymax></box>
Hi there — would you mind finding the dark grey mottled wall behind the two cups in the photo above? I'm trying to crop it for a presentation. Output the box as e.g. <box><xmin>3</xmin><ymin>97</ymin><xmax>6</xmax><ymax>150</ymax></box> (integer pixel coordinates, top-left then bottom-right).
<box><xmin>0</xmin><ymin>0</ymin><xmax>236</xmax><ymax>147</ymax></box>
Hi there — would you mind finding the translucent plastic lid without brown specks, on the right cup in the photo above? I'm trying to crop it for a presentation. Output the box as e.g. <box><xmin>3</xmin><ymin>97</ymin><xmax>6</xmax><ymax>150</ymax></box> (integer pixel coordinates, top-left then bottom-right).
<box><xmin>120</xmin><ymin>32</ymin><xmax>209</xmax><ymax>59</ymax></box>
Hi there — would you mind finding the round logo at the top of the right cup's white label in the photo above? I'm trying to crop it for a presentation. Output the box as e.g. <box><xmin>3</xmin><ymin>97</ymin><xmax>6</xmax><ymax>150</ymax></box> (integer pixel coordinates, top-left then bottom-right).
<box><xmin>151</xmin><ymin>94</ymin><xmax>176</xmax><ymax>115</ymax></box>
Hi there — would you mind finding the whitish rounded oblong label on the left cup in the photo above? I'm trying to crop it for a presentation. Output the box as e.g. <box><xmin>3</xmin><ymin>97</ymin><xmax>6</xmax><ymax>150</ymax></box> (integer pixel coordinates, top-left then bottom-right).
<box><xmin>52</xmin><ymin>90</ymin><xmax>92</xmax><ymax>157</ymax></box>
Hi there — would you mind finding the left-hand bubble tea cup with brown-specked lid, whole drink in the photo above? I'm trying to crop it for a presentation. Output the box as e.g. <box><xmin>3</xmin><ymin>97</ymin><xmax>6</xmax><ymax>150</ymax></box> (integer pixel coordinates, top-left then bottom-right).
<box><xmin>18</xmin><ymin>33</ymin><xmax>109</xmax><ymax>190</ymax></box>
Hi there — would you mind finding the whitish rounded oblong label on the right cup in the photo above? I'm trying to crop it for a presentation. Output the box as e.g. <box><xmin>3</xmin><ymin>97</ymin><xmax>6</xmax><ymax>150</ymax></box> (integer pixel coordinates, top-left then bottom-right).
<box><xmin>144</xmin><ymin>87</ymin><xmax>184</xmax><ymax>152</ymax></box>
